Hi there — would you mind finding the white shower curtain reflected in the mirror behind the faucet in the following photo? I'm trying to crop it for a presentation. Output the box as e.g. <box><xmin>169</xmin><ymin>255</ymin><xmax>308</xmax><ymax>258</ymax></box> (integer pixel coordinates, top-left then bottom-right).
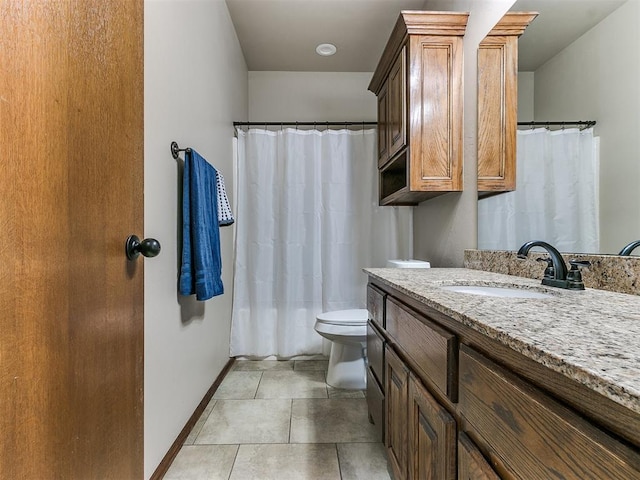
<box><xmin>478</xmin><ymin>128</ymin><xmax>600</xmax><ymax>253</ymax></box>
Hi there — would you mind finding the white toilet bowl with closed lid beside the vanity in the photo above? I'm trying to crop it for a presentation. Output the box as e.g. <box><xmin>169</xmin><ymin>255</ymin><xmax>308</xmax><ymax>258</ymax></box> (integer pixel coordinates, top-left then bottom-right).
<box><xmin>313</xmin><ymin>309</ymin><xmax>369</xmax><ymax>390</ymax></box>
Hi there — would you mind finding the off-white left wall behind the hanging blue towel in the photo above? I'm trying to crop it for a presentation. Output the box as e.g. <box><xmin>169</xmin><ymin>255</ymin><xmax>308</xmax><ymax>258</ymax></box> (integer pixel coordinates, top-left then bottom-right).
<box><xmin>144</xmin><ymin>0</ymin><xmax>248</xmax><ymax>478</ymax></box>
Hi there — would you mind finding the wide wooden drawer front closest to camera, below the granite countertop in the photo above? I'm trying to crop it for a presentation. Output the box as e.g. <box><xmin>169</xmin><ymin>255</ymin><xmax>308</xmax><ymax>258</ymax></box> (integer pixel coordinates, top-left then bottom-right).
<box><xmin>459</xmin><ymin>345</ymin><xmax>640</xmax><ymax>480</ymax></box>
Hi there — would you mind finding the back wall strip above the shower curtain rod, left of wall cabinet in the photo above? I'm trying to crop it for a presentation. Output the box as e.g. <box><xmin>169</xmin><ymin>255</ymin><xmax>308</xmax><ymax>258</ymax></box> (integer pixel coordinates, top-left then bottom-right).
<box><xmin>249</xmin><ymin>72</ymin><xmax>377</xmax><ymax>122</ymax></box>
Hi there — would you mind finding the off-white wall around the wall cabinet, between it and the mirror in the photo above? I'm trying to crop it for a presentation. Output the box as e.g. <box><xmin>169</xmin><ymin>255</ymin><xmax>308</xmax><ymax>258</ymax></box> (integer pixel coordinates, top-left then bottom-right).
<box><xmin>413</xmin><ymin>0</ymin><xmax>515</xmax><ymax>267</ymax></box>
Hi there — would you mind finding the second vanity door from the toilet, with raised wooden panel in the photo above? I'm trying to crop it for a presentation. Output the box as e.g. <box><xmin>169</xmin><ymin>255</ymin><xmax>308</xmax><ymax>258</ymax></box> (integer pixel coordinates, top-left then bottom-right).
<box><xmin>408</xmin><ymin>375</ymin><xmax>456</xmax><ymax>480</ymax></box>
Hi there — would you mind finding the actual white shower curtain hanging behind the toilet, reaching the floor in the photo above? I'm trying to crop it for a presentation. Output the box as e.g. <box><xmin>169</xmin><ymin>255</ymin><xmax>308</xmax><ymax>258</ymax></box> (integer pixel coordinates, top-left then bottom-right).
<box><xmin>231</xmin><ymin>128</ymin><xmax>412</xmax><ymax>358</ymax></box>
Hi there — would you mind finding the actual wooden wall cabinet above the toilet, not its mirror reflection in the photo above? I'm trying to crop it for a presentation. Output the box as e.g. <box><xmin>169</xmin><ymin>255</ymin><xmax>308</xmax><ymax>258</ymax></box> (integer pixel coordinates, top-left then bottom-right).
<box><xmin>369</xmin><ymin>11</ymin><xmax>468</xmax><ymax>205</ymax></box>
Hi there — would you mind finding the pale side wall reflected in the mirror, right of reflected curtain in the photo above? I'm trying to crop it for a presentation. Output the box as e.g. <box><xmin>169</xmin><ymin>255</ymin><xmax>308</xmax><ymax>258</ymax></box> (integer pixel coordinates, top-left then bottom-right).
<box><xmin>535</xmin><ymin>0</ymin><xmax>640</xmax><ymax>253</ymax></box>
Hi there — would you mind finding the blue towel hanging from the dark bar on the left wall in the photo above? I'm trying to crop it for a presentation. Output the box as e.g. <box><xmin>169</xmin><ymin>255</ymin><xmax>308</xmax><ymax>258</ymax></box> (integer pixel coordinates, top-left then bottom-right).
<box><xmin>180</xmin><ymin>149</ymin><xmax>224</xmax><ymax>300</ymax></box>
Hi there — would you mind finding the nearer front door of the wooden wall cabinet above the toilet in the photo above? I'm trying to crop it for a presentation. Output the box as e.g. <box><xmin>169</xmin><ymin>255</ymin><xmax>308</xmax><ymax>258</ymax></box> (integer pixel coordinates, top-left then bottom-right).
<box><xmin>388</xmin><ymin>47</ymin><xmax>407</xmax><ymax>158</ymax></box>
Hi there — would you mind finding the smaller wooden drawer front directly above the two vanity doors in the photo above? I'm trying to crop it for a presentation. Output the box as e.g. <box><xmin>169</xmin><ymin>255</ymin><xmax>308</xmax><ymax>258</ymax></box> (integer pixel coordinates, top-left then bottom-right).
<box><xmin>386</xmin><ymin>297</ymin><xmax>458</xmax><ymax>402</ymax></box>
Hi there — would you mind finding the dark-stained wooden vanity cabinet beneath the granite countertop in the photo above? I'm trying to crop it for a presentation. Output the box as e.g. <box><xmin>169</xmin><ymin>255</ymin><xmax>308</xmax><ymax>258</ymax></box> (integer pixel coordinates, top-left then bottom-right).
<box><xmin>367</xmin><ymin>283</ymin><xmax>640</xmax><ymax>480</ymax></box>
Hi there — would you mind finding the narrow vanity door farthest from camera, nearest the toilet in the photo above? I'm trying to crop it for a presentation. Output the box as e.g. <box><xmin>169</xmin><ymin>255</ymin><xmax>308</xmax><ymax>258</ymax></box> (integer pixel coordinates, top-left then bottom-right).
<box><xmin>385</xmin><ymin>347</ymin><xmax>409</xmax><ymax>480</ymax></box>
